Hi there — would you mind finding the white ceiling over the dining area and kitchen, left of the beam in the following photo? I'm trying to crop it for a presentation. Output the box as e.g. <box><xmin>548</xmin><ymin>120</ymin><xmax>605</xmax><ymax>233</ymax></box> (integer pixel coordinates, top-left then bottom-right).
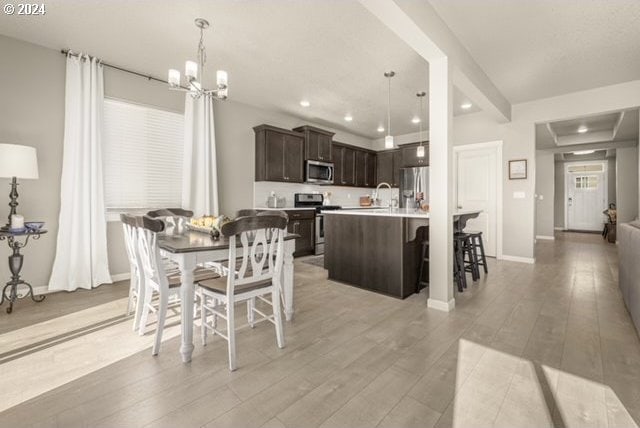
<box><xmin>0</xmin><ymin>0</ymin><xmax>477</xmax><ymax>139</ymax></box>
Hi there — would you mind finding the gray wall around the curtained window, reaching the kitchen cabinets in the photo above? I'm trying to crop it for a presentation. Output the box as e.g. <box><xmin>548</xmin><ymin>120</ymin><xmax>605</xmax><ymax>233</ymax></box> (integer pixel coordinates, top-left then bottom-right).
<box><xmin>0</xmin><ymin>36</ymin><xmax>372</xmax><ymax>286</ymax></box>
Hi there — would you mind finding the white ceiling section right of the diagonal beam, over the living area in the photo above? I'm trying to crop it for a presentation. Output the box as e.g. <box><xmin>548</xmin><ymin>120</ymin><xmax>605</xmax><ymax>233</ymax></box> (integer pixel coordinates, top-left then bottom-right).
<box><xmin>429</xmin><ymin>0</ymin><xmax>640</xmax><ymax>104</ymax></box>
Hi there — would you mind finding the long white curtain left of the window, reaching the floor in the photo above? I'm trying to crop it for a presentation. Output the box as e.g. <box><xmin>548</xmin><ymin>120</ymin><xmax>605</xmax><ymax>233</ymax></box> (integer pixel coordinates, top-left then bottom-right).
<box><xmin>49</xmin><ymin>55</ymin><xmax>111</xmax><ymax>291</ymax></box>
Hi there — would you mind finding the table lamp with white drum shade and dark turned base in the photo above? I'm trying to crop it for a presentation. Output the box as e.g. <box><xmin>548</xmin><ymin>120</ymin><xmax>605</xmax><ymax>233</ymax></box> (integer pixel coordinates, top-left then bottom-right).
<box><xmin>0</xmin><ymin>144</ymin><xmax>38</xmax><ymax>229</ymax></box>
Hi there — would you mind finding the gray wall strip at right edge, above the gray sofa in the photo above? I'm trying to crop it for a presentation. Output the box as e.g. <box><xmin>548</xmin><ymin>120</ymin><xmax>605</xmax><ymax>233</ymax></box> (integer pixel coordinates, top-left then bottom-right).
<box><xmin>616</xmin><ymin>147</ymin><xmax>638</xmax><ymax>223</ymax></box>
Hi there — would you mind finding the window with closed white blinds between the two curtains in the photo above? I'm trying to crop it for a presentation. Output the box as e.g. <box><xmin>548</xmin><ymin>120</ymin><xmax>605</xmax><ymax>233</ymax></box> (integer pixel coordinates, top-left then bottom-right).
<box><xmin>102</xmin><ymin>99</ymin><xmax>184</xmax><ymax>212</ymax></box>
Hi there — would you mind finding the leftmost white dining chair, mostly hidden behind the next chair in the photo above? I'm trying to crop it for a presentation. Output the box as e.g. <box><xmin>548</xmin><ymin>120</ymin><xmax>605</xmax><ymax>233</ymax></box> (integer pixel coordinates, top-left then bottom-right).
<box><xmin>120</xmin><ymin>214</ymin><xmax>144</xmax><ymax>331</ymax></box>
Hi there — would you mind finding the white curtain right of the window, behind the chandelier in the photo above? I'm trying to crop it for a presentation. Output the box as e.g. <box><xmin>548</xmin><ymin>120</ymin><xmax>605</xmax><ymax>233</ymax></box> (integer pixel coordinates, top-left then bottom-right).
<box><xmin>182</xmin><ymin>94</ymin><xmax>218</xmax><ymax>216</ymax></box>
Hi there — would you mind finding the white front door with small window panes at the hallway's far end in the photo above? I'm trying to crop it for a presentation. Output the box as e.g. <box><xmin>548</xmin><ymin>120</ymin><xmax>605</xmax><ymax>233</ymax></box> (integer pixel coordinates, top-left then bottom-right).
<box><xmin>566</xmin><ymin>171</ymin><xmax>607</xmax><ymax>231</ymax></box>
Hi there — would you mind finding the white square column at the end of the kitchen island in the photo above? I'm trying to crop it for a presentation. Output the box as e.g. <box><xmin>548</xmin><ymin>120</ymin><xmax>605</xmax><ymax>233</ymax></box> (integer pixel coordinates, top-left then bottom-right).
<box><xmin>427</xmin><ymin>57</ymin><xmax>455</xmax><ymax>311</ymax></box>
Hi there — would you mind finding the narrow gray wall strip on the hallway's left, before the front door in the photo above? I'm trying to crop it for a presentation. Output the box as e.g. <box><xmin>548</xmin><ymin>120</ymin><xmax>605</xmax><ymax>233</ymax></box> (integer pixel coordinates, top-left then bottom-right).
<box><xmin>536</xmin><ymin>150</ymin><xmax>555</xmax><ymax>237</ymax></box>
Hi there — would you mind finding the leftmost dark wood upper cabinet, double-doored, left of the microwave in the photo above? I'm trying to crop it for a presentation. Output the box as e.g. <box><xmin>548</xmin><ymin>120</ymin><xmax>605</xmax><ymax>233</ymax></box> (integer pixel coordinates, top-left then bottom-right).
<box><xmin>253</xmin><ymin>125</ymin><xmax>305</xmax><ymax>183</ymax></box>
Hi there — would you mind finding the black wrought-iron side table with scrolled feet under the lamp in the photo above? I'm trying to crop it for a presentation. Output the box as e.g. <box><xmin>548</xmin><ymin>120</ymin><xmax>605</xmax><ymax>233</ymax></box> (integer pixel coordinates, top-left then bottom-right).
<box><xmin>0</xmin><ymin>229</ymin><xmax>47</xmax><ymax>314</ymax></box>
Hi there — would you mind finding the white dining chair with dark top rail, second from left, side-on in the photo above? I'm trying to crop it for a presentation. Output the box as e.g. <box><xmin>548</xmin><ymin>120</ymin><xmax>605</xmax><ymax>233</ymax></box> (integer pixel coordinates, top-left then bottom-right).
<box><xmin>137</xmin><ymin>216</ymin><xmax>219</xmax><ymax>355</ymax></box>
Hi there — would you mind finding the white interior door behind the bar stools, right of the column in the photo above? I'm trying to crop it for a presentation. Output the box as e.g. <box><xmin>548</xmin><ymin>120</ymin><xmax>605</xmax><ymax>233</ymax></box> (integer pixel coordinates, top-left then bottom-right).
<box><xmin>455</xmin><ymin>146</ymin><xmax>498</xmax><ymax>257</ymax></box>
